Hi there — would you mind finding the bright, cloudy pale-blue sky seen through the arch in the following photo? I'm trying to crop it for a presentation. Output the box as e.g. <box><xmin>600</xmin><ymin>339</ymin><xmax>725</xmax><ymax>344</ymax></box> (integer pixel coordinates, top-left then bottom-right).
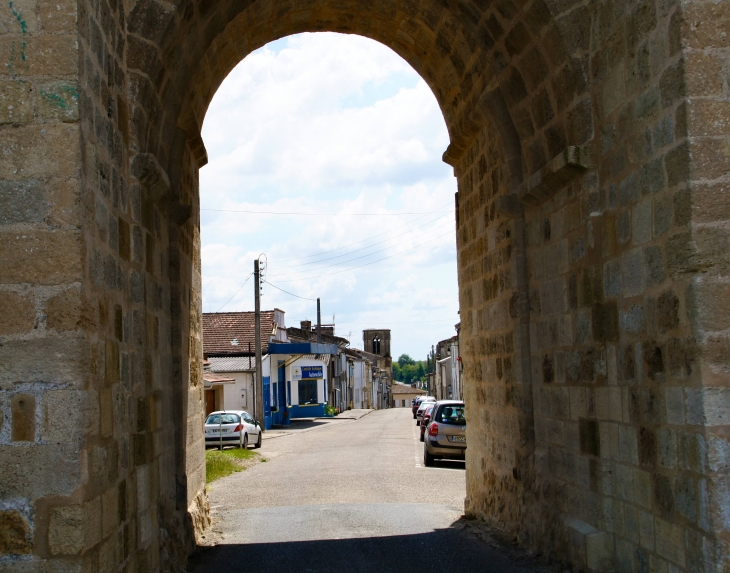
<box><xmin>200</xmin><ymin>33</ymin><xmax>459</xmax><ymax>359</ymax></box>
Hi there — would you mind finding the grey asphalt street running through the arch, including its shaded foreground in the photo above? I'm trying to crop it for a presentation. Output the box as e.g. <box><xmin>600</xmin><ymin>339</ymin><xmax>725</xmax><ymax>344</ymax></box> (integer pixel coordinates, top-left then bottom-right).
<box><xmin>189</xmin><ymin>408</ymin><xmax>542</xmax><ymax>573</ymax></box>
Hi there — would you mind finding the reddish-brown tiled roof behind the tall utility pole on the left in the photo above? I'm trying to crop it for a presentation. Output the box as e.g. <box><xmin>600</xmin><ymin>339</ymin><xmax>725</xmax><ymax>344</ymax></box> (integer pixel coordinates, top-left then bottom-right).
<box><xmin>203</xmin><ymin>310</ymin><xmax>274</xmax><ymax>356</ymax></box>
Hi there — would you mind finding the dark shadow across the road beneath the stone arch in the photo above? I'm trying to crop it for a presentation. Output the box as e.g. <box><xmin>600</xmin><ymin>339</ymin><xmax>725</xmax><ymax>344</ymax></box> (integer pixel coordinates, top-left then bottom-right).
<box><xmin>188</xmin><ymin>520</ymin><xmax>552</xmax><ymax>573</ymax></box>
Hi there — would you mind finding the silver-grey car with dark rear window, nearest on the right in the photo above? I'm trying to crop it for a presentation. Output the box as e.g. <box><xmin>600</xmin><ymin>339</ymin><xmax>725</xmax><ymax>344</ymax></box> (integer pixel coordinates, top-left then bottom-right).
<box><xmin>423</xmin><ymin>400</ymin><xmax>466</xmax><ymax>466</ymax></box>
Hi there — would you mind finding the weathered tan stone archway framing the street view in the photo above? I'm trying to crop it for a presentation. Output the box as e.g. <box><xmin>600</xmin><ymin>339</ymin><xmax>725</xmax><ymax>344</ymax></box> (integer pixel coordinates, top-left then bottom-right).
<box><xmin>0</xmin><ymin>0</ymin><xmax>730</xmax><ymax>573</ymax></box>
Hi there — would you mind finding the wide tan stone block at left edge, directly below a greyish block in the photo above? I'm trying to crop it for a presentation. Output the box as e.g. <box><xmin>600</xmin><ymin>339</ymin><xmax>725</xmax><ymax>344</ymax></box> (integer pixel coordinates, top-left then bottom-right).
<box><xmin>0</xmin><ymin>231</ymin><xmax>83</xmax><ymax>285</ymax></box>
